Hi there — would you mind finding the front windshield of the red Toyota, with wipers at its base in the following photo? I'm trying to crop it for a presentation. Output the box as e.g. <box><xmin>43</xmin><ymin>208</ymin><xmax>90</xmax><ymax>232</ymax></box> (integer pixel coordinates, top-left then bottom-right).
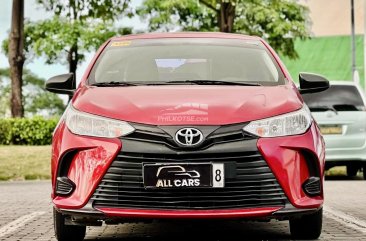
<box><xmin>89</xmin><ymin>38</ymin><xmax>284</xmax><ymax>86</ymax></box>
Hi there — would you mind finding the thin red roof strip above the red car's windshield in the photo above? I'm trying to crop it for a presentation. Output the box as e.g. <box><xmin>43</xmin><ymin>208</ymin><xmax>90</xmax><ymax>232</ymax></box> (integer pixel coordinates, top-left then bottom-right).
<box><xmin>111</xmin><ymin>32</ymin><xmax>261</xmax><ymax>41</ymax></box>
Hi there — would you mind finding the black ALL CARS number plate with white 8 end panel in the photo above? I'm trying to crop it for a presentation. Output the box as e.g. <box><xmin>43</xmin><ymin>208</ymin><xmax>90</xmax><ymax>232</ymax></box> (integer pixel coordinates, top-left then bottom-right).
<box><xmin>143</xmin><ymin>163</ymin><xmax>225</xmax><ymax>189</ymax></box>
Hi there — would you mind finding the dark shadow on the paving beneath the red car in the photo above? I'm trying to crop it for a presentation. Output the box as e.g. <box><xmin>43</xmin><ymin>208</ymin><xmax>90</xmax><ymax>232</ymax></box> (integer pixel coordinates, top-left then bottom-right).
<box><xmin>85</xmin><ymin>221</ymin><xmax>291</xmax><ymax>241</ymax></box>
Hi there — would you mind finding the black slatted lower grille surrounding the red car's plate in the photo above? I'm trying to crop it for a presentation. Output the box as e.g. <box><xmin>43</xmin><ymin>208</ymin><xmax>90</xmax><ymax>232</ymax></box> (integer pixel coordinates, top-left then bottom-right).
<box><xmin>92</xmin><ymin>151</ymin><xmax>286</xmax><ymax>210</ymax></box>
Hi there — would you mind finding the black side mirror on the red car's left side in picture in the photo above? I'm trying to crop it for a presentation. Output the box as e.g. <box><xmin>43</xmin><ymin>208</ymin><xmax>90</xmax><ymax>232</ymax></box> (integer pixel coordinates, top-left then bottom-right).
<box><xmin>45</xmin><ymin>73</ymin><xmax>76</xmax><ymax>96</ymax></box>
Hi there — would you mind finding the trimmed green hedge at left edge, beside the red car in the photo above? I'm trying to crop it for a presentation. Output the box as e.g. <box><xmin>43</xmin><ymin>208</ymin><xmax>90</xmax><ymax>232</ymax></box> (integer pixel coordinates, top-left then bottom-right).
<box><xmin>0</xmin><ymin>116</ymin><xmax>58</xmax><ymax>145</ymax></box>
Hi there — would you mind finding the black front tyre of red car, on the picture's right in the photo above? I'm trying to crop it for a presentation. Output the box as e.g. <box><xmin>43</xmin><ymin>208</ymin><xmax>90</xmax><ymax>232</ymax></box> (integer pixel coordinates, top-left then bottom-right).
<box><xmin>290</xmin><ymin>208</ymin><xmax>323</xmax><ymax>240</ymax></box>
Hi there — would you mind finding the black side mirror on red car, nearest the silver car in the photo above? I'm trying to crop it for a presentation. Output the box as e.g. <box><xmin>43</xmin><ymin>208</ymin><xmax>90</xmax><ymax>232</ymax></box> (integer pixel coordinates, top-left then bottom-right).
<box><xmin>299</xmin><ymin>73</ymin><xmax>329</xmax><ymax>94</ymax></box>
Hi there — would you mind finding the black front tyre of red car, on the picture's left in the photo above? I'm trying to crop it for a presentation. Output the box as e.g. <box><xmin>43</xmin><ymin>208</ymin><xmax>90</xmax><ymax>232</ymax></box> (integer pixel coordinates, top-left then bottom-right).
<box><xmin>53</xmin><ymin>208</ymin><xmax>86</xmax><ymax>241</ymax></box>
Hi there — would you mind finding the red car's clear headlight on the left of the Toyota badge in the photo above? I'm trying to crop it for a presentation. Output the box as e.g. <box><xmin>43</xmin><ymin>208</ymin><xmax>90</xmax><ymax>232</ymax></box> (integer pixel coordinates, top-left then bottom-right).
<box><xmin>66</xmin><ymin>105</ymin><xmax>135</xmax><ymax>138</ymax></box>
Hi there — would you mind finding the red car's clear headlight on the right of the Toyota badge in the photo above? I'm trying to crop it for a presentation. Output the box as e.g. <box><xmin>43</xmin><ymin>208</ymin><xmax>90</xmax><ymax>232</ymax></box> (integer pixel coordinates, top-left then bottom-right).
<box><xmin>243</xmin><ymin>105</ymin><xmax>312</xmax><ymax>137</ymax></box>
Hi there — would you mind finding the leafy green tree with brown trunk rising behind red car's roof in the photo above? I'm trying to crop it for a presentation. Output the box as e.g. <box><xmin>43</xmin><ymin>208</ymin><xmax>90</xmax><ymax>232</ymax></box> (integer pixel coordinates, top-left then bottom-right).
<box><xmin>137</xmin><ymin>0</ymin><xmax>309</xmax><ymax>58</ymax></box>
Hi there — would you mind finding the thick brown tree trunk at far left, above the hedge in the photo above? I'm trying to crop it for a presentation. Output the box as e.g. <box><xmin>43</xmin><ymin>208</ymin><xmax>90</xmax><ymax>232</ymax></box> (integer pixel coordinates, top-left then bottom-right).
<box><xmin>8</xmin><ymin>0</ymin><xmax>24</xmax><ymax>117</ymax></box>
